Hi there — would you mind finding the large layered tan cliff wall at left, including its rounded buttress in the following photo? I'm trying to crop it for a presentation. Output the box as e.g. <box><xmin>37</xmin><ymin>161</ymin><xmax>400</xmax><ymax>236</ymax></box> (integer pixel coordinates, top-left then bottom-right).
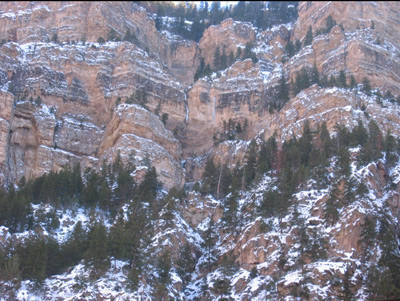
<box><xmin>0</xmin><ymin>28</ymin><xmax>186</xmax><ymax>188</ymax></box>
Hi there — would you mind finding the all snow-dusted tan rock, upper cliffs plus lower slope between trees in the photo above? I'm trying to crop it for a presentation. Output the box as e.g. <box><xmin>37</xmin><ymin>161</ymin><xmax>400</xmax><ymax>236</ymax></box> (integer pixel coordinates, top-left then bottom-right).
<box><xmin>0</xmin><ymin>2</ymin><xmax>400</xmax><ymax>300</ymax></box>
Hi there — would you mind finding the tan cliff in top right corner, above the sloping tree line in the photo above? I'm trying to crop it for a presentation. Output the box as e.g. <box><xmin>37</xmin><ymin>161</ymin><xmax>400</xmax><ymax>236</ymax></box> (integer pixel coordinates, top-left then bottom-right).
<box><xmin>288</xmin><ymin>1</ymin><xmax>400</xmax><ymax>95</ymax></box>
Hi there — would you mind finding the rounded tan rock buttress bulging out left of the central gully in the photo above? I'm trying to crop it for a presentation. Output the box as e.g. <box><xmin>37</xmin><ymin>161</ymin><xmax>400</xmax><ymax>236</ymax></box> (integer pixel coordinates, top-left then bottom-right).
<box><xmin>99</xmin><ymin>105</ymin><xmax>183</xmax><ymax>188</ymax></box>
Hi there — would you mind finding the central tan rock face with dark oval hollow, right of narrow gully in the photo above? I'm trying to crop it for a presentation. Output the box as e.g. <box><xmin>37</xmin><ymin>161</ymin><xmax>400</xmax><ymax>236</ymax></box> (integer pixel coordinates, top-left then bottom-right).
<box><xmin>183</xmin><ymin>59</ymin><xmax>281</xmax><ymax>158</ymax></box>
